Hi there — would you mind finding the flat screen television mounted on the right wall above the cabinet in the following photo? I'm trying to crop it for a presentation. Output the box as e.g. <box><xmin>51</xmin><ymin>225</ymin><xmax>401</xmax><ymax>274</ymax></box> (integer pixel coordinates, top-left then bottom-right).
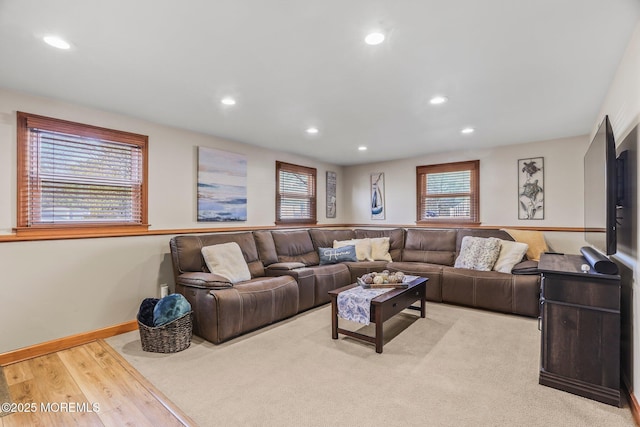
<box><xmin>584</xmin><ymin>116</ymin><xmax>618</xmax><ymax>255</ymax></box>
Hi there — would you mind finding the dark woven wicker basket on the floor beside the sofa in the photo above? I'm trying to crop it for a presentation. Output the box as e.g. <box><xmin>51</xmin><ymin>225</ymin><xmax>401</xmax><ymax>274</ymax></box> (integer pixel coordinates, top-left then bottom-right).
<box><xmin>138</xmin><ymin>311</ymin><xmax>193</xmax><ymax>353</ymax></box>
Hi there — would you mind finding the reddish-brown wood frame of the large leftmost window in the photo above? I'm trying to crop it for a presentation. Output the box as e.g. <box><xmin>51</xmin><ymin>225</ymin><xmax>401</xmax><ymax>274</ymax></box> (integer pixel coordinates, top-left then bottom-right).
<box><xmin>14</xmin><ymin>111</ymin><xmax>149</xmax><ymax>238</ymax></box>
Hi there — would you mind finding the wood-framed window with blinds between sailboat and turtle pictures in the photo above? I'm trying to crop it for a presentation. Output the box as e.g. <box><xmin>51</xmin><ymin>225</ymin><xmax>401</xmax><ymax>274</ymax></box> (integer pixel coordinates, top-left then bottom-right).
<box><xmin>416</xmin><ymin>160</ymin><xmax>480</xmax><ymax>223</ymax></box>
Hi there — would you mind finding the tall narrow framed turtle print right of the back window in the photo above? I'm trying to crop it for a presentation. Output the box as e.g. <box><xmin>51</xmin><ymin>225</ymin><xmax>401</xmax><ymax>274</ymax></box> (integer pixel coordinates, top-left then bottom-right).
<box><xmin>518</xmin><ymin>157</ymin><xmax>544</xmax><ymax>219</ymax></box>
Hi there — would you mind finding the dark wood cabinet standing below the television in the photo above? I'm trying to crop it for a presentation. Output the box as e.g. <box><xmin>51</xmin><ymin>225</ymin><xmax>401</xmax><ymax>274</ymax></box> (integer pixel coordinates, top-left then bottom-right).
<box><xmin>539</xmin><ymin>254</ymin><xmax>621</xmax><ymax>406</ymax></box>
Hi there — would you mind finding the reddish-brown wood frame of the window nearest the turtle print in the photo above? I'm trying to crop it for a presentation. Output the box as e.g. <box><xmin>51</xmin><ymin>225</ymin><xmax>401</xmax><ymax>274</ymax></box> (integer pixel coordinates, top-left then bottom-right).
<box><xmin>416</xmin><ymin>160</ymin><xmax>480</xmax><ymax>226</ymax></box>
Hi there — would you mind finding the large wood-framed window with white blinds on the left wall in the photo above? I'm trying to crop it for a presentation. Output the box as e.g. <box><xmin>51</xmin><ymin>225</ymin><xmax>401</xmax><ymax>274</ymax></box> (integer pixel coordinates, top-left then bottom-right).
<box><xmin>18</xmin><ymin>112</ymin><xmax>148</xmax><ymax>236</ymax></box>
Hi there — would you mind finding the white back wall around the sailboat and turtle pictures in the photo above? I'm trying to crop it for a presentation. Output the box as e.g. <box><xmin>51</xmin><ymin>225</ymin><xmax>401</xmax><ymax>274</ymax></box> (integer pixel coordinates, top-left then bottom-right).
<box><xmin>344</xmin><ymin>135</ymin><xmax>589</xmax><ymax>253</ymax></box>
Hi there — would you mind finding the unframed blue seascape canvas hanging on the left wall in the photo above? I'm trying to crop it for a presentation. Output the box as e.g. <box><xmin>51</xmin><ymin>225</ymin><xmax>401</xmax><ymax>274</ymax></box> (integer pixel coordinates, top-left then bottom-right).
<box><xmin>198</xmin><ymin>147</ymin><xmax>247</xmax><ymax>221</ymax></box>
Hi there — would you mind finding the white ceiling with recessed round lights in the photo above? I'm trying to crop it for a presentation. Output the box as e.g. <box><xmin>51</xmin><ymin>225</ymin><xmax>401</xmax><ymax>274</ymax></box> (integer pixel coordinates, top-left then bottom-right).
<box><xmin>0</xmin><ymin>0</ymin><xmax>640</xmax><ymax>165</ymax></box>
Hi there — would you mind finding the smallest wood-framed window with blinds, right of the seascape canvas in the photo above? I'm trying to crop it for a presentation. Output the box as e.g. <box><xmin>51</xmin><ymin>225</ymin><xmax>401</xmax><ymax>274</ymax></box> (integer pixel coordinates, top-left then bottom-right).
<box><xmin>276</xmin><ymin>162</ymin><xmax>317</xmax><ymax>224</ymax></box>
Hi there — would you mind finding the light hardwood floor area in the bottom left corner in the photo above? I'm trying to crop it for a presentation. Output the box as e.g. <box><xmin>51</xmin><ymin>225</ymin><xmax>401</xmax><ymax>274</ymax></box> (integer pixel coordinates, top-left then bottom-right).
<box><xmin>0</xmin><ymin>340</ymin><xmax>196</xmax><ymax>427</ymax></box>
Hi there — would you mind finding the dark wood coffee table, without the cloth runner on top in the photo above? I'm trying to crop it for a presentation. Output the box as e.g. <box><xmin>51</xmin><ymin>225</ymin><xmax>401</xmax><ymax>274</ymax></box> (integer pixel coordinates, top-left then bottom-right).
<box><xmin>329</xmin><ymin>277</ymin><xmax>428</xmax><ymax>353</ymax></box>
